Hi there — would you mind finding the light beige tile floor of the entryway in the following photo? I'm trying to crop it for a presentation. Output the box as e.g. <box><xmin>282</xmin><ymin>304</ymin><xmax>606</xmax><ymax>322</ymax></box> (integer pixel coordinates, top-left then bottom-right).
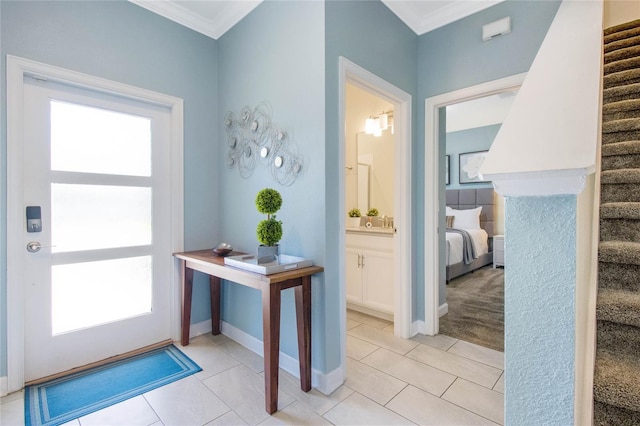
<box><xmin>0</xmin><ymin>311</ymin><xmax>504</xmax><ymax>426</ymax></box>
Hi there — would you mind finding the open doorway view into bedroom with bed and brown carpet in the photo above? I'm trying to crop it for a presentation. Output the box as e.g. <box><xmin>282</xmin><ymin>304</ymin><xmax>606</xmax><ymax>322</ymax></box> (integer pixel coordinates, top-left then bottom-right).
<box><xmin>439</xmin><ymin>90</ymin><xmax>517</xmax><ymax>352</ymax></box>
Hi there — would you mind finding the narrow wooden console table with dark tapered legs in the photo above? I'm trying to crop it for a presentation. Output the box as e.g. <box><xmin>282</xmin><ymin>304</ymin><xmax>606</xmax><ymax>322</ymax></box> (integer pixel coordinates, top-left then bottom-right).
<box><xmin>174</xmin><ymin>250</ymin><xmax>324</xmax><ymax>414</ymax></box>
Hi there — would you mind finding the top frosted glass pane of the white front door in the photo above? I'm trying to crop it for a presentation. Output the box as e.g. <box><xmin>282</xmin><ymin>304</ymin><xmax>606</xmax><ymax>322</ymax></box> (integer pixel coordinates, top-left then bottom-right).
<box><xmin>51</xmin><ymin>100</ymin><xmax>151</xmax><ymax>176</ymax></box>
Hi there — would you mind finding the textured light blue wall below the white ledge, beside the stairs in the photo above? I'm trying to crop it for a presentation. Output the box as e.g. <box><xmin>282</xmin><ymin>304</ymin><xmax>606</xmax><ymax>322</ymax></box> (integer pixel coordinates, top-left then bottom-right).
<box><xmin>504</xmin><ymin>195</ymin><xmax>577</xmax><ymax>426</ymax></box>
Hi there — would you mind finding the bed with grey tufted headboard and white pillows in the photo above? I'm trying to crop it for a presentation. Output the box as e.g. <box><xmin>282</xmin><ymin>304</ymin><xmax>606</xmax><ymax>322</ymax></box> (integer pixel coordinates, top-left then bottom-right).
<box><xmin>445</xmin><ymin>188</ymin><xmax>494</xmax><ymax>282</ymax></box>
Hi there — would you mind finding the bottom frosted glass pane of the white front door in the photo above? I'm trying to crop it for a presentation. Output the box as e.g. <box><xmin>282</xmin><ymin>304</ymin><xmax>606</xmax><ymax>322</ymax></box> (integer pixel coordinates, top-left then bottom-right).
<box><xmin>51</xmin><ymin>256</ymin><xmax>152</xmax><ymax>335</ymax></box>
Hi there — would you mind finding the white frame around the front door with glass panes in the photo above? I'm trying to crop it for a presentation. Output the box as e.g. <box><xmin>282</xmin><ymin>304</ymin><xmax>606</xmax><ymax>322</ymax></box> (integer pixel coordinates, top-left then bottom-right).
<box><xmin>7</xmin><ymin>55</ymin><xmax>184</xmax><ymax>392</ymax></box>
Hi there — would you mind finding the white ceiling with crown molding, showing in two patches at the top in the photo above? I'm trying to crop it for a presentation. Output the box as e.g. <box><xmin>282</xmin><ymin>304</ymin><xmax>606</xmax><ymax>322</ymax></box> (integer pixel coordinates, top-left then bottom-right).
<box><xmin>129</xmin><ymin>0</ymin><xmax>504</xmax><ymax>39</ymax></box>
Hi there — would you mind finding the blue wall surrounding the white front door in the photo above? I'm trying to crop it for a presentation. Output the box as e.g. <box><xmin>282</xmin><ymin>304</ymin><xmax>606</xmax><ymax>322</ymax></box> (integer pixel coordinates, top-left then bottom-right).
<box><xmin>0</xmin><ymin>1</ymin><xmax>219</xmax><ymax>376</ymax></box>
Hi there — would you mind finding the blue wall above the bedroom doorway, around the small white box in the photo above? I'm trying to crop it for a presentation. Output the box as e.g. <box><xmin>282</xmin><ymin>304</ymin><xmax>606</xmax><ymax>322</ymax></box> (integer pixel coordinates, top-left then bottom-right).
<box><xmin>413</xmin><ymin>0</ymin><xmax>560</xmax><ymax>312</ymax></box>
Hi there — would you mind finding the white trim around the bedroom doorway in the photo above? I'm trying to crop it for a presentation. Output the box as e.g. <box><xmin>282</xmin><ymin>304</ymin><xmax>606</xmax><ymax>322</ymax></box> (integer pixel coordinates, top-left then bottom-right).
<box><xmin>420</xmin><ymin>73</ymin><xmax>526</xmax><ymax>336</ymax></box>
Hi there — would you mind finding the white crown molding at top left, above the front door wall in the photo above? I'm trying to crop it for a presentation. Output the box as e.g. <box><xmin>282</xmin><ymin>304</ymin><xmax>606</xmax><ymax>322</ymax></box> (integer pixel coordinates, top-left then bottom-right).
<box><xmin>129</xmin><ymin>0</ymin><xmax>262</xmax><ymax>40</ymax></box>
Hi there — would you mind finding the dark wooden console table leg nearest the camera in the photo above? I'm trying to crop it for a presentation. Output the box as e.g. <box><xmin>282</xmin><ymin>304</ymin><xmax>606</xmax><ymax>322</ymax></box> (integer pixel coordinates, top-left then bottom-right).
<box><xmin>262</xmin><ymin>285</ymin><xmax>280</xmax><ymax>414</ymax></box>
